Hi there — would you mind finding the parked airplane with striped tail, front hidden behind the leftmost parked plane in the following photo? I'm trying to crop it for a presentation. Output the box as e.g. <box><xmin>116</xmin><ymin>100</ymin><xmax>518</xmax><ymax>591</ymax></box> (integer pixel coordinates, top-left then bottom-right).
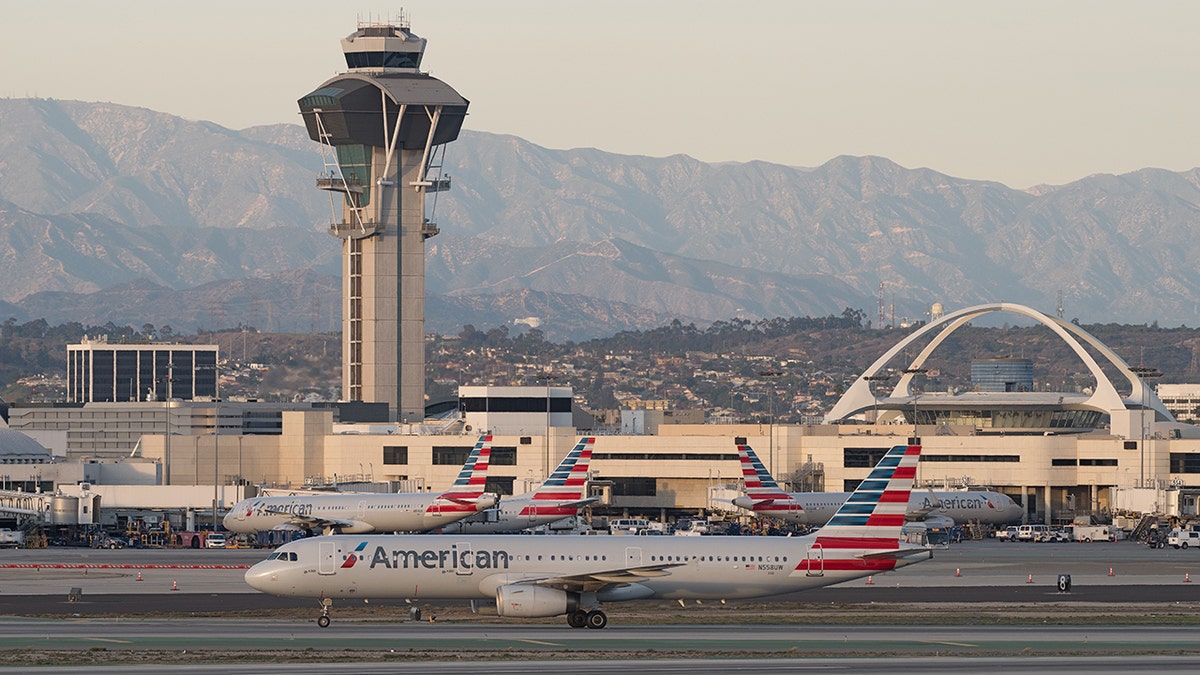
<box><xmin>439</xmin><ymin>436</ymin><xmax>598</xmax><ymax>534</ymax></box>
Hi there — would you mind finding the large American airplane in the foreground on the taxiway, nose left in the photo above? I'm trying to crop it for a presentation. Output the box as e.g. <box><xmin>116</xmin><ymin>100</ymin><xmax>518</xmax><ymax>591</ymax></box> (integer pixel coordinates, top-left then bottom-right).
<box><xmin>245</xmin><ymin>446</ymin><xmax>932</xmax><ymax>629</ymax></box>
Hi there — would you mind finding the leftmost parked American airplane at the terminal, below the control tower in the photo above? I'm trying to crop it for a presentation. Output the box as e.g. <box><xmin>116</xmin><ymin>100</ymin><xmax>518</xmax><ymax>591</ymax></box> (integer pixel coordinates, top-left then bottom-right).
<box><xmin>223</xmin><ymin>435</ymin><xmax>499</xmax><ymax>534</ymax></box>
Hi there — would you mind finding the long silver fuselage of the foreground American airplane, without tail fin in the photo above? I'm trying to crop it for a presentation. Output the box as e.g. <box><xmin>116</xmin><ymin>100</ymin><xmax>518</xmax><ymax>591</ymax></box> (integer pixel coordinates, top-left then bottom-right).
<box><xmin>246</xmin><ymin>534</ymin><xmax>929</xmax><ymax>602</ymax></box>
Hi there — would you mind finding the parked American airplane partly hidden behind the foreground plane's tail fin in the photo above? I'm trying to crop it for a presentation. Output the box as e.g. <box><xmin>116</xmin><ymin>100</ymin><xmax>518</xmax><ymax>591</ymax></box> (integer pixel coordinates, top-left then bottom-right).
<box><xmin>733</xmin><ymin>444</ymin><xmax>1024</xmax><ymax>527</ymax></box>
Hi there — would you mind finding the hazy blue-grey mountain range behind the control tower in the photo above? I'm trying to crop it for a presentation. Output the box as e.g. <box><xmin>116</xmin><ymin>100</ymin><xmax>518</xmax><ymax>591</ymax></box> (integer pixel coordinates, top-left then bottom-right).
<box><xmin>0</xmin><ymin>98</ymin><xmax>1200</xmax><ymax>340</ymax></box>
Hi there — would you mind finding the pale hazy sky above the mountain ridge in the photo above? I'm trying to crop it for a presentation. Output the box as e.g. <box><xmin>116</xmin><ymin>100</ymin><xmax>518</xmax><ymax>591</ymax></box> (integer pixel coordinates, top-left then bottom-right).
<box><xmin>0</xmin><ymin>0</ymin><xmax>1200</xmax><ymax>187</ymax></box>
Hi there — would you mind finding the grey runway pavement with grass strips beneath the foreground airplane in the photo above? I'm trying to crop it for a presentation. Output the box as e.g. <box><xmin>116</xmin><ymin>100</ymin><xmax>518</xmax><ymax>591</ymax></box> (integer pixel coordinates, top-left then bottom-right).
<box><xmin>0</xmin><ymin>540</ymin><xmax>1200</xmax><ymax>673</ymax></box>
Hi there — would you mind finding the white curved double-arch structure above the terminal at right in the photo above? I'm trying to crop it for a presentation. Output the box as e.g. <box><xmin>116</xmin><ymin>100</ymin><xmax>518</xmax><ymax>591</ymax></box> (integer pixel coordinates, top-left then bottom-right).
<box><xmin>824</xmin><ymin>303</ymin><xmax>1175</xmax><ymax>435</ymax></box>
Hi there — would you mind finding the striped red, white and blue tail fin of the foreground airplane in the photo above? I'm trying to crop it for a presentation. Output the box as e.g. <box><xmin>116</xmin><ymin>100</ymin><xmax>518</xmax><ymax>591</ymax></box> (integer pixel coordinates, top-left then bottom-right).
<box><xmin>816</xmin><ymin>446</ymin><xmax>920</xmax><ymax>549</ymax></box>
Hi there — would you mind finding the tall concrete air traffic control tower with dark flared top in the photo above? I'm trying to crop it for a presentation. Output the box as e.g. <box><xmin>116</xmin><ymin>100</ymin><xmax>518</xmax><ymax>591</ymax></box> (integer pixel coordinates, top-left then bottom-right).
<box><xmin>299</xmin><ymin>20</ymin><xmax>469</xmax><ymax>422</ymax></box>
